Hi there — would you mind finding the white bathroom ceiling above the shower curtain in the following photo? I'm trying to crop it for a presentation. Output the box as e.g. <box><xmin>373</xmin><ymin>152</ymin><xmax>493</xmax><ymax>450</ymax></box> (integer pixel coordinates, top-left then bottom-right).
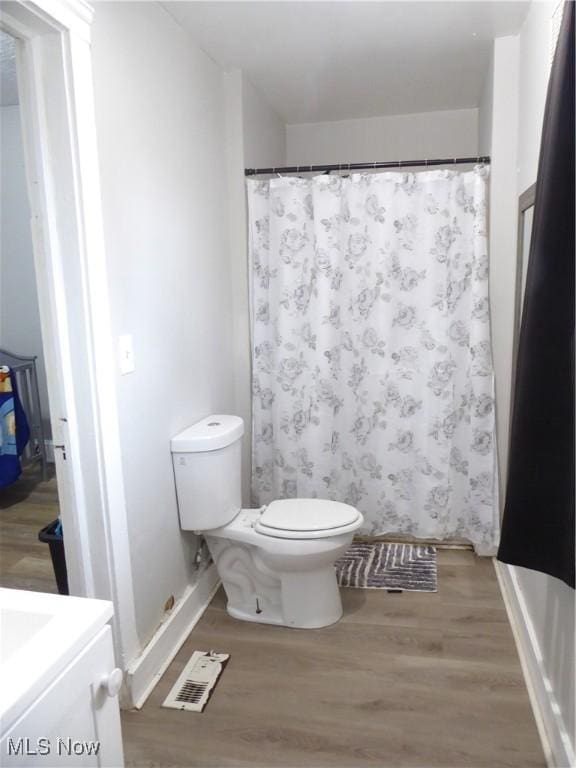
<box><xmin>163</xmin><ymin>0</ymin><xmax>529</xmax><ymax>123</ymax></box>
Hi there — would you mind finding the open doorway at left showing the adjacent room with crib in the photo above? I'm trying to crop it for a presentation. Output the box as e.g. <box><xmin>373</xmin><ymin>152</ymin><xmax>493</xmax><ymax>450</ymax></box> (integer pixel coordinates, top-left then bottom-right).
<box><xmin>0</xmin><ymin>32</ymin><xmax>61</xmax><ymax>594</ymax></box>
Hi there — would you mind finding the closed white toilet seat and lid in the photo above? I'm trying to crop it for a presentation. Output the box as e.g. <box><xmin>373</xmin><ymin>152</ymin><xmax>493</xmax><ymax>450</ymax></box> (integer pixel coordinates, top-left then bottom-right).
<box><xmin>254</xmin><ymin>499</ymin><xmax>362</xmax><ymax>539</ymax></box>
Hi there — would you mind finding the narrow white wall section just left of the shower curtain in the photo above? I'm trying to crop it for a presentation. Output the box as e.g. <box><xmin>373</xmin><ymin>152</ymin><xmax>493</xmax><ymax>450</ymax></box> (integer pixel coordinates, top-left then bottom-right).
<box><xmin>224</xmin><ymin>70</ymin><xmax>286</xmax><ymax>506</ymax></box>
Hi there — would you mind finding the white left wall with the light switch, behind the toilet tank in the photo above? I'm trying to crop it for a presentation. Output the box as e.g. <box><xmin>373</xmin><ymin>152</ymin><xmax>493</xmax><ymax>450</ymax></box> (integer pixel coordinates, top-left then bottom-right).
<box><xmin>93</xmin><ymin>3</ymin><xmax>234</xmax><ymax>646</ymax></box>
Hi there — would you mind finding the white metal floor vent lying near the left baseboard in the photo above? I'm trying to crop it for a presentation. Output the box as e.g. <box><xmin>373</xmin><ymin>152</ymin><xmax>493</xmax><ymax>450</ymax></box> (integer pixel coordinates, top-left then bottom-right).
<box><xmin>162</xmin><ymin>651</ymin><xmax>230</xmax><ymax>712</ymax></box>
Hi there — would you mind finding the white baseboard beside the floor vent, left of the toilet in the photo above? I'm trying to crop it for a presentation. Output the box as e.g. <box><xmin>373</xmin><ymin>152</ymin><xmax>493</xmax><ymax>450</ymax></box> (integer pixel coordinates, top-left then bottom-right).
<box><xmin>126</xmin><ymin>564</ymin><xmax>220</xmax><ymax>709</ymax></box>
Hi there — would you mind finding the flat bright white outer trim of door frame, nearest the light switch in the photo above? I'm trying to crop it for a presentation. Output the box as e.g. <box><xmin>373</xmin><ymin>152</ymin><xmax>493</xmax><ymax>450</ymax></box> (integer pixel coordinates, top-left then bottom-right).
<box><xmin>62</xmin><ymin>12</ymin><xmax>139</xmax><ymax>665</ymax></box>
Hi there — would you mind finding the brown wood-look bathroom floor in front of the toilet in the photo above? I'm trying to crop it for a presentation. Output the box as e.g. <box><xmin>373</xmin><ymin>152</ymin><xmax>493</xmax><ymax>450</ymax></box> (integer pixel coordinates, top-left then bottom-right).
<box><xmin>123</xmin><ymin>550</ymin><xmax>546</xmax><ymax>768</ymax></box>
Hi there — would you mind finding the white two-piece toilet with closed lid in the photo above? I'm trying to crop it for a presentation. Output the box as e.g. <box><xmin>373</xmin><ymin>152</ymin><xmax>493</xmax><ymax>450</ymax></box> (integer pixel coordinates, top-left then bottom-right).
<box><xmin>171</xmin><ymin>415</ymin><xmax>363</xmax><ymax>629</ymax></box>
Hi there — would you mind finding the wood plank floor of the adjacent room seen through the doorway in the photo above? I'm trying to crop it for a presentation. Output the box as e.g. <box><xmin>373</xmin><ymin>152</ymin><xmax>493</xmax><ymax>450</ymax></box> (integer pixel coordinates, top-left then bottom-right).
<box><xmin>0</xmin><ymin>467</ymin><xmax>59</xmax><ymax>593</ymax></box>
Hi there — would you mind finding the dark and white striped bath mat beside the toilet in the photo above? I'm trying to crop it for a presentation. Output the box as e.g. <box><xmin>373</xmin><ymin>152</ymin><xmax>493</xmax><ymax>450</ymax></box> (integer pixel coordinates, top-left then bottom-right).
<box><xmin>336</xmin><ymin>541</ymin><xmax>438</xmax><ymax>592</ymax></box>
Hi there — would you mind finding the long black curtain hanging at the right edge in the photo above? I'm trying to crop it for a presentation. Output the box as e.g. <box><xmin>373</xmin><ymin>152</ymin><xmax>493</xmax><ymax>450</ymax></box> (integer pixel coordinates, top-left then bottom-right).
<box><xmin>498</xmin><ymin>2</ymin><xmax>575</xmax><ymax>587</ymax></box>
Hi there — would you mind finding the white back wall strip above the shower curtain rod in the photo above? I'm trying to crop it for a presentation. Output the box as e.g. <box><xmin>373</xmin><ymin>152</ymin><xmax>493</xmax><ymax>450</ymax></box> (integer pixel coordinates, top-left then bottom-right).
<box><xmin>286</xmin><ymin>109</ymin><xmax>478</xmax><ymax>165</ymax></box>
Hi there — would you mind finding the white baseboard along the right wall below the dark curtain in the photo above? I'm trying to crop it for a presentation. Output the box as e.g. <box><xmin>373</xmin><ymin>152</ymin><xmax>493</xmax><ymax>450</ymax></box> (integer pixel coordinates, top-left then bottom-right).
<box><xmin>494</xmin><ymin>560</ymin><xmax>576</xmax><ymax>768</ymax></box>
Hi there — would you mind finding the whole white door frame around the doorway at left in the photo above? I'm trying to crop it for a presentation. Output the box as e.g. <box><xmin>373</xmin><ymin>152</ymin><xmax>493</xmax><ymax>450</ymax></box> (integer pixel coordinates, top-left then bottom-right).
<box><xmin>0</xmin><ymin>0</ymin><xmax>140</xmax><ymax>669</ymax></box>
